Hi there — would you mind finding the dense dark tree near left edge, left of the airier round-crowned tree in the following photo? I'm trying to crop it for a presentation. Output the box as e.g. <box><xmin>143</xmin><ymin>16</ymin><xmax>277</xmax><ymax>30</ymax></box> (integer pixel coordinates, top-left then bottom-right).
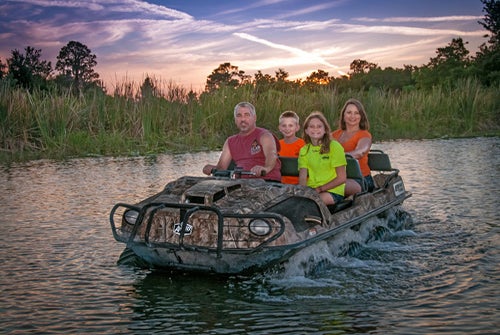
<box><xmin>7</xmin><ymin>46</ymin><xmax>52</xmax><ymax>88</ymax></box>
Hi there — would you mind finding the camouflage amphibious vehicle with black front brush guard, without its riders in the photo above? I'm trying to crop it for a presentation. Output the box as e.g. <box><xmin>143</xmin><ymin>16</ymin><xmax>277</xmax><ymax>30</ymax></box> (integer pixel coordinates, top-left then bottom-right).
<box><xmin>110</xmin><ymin>151</ymin><xmax>411</xmax><ymax>274</ymax></box>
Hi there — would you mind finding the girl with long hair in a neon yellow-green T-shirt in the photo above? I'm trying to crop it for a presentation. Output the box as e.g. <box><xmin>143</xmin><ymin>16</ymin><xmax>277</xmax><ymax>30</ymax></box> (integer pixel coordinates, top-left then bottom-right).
<box><xmin>298</xmin><ymin>112</ymin><xmax>347</xmax><ymax>205</ymax></box>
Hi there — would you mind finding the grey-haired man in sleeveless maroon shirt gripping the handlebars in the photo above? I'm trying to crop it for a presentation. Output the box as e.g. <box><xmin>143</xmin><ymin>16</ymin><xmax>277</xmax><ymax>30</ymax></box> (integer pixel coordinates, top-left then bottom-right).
<box><xmin>203</xmin><ymin>102</ymin><xmax>281</xmax><ymax>182</ymax></box>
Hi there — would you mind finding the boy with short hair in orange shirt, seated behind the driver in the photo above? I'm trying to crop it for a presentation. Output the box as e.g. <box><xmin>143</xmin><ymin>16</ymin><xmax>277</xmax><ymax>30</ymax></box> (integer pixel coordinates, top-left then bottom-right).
<box><xmin>278</xmin><ymin>111</ymin><xmax>305</xmax><ymax>184</ymax></box>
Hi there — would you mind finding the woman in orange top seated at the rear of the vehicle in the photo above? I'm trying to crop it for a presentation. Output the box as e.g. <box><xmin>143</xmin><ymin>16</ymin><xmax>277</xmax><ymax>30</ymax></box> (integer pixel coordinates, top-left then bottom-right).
<box><xmin>332</xmin><ymin>99</ymin><xmax>374</xmax><ymax>197</ymax></box>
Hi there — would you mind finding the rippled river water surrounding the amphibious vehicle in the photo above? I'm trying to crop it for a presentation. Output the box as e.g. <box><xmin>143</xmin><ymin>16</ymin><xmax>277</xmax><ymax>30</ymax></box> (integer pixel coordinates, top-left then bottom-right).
<box><xmin>0</xmin><ymin>138</ymin><xmax>500</xmax><ymax>335</ymax></box>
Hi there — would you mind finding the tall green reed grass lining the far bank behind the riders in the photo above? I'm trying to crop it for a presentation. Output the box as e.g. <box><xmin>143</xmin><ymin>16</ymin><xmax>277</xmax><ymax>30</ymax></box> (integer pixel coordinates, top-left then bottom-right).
<box><xmin>0</xmin><ymin>79</ymin><xmax>500</xmax><ymax>162</ymax></box>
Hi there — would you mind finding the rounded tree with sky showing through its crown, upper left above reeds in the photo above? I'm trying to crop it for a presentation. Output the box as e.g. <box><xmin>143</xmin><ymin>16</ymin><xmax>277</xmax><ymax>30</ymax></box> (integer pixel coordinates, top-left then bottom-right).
<box><xmin>56</xmin><ymin>41</ymin><xmax>99</xmax><ymax>89</ymax></box>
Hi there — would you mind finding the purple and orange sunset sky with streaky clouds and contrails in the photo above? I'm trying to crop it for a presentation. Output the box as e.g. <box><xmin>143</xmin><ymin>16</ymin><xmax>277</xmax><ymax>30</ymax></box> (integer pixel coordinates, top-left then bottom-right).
<box><xmin>0</xmin><ymin>0</ymin><xmax>487</xmax><ymax>91</ymax></box>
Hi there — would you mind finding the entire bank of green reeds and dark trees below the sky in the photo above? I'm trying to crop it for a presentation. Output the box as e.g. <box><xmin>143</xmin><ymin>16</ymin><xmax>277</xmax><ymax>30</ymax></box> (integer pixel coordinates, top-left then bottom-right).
<box><xmin>0</xmin><ymin>0</ymin><xmax>500</xmax><ymax>163</ymax></box>
